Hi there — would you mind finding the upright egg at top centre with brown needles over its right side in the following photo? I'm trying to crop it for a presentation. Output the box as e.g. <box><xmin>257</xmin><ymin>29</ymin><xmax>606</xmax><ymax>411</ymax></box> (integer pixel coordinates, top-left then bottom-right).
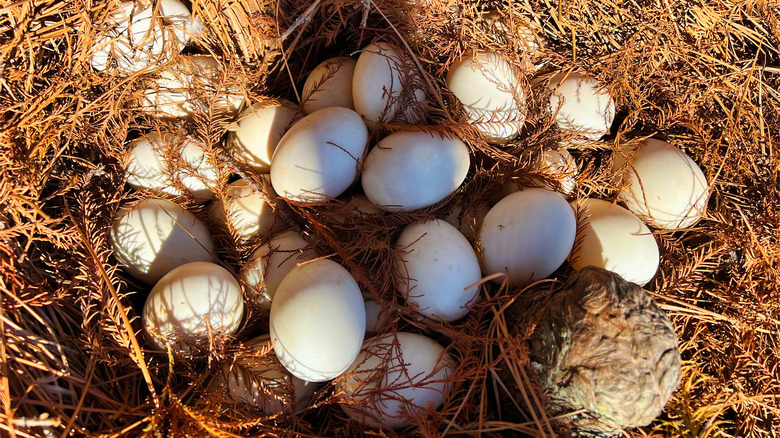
<box><xmin>352</xmin><ymin>42</ymin><xmax>404</xmax><ymax>122</ymax></box>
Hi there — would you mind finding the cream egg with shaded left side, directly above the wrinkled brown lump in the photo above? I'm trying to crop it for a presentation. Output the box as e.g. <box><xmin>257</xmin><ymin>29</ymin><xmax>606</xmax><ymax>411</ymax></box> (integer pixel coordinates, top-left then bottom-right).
<box><xmin>569</xmin><ymin>198</ymin><xmax>659</xmax><ymax>286</ymax></box>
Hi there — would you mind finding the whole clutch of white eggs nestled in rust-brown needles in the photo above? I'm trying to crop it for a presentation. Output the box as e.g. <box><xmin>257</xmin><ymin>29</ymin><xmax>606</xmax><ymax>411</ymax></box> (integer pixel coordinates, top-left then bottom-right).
<box><xmin>92</xmin><ymin>0</ymin><xmax>709</xmax><ymax>428</ymax></box>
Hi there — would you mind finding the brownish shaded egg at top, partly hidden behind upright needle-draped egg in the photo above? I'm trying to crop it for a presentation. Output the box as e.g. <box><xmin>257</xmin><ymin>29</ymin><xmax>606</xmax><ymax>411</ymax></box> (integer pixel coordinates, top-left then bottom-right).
<box><xmin>301</xmin><ymin>56</ymin><xmax>357</xmax><ymax>113</ymax></box>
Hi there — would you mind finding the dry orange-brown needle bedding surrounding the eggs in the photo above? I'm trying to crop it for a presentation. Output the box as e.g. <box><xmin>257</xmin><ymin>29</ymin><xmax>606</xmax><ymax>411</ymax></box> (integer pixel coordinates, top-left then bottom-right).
<box><xmin>0</xmin><ymin>0</ymin><xmax>780</xmax><ymax>437</ymax></box>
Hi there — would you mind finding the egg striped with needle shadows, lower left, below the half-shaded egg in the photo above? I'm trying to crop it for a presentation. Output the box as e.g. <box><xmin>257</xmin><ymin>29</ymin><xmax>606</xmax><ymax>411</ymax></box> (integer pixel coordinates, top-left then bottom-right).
<box><xmin>142</xmin><ymin>262</ymin><xmax>244</xmax><ymax>352</ymax></box>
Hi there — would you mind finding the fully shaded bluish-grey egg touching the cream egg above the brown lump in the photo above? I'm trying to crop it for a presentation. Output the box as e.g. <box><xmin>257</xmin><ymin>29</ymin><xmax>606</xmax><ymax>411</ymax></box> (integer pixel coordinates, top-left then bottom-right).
<box><xmin>479</xmin><ymin>188</ymin><xmax>577</xmax><ymax>286</ymax></box>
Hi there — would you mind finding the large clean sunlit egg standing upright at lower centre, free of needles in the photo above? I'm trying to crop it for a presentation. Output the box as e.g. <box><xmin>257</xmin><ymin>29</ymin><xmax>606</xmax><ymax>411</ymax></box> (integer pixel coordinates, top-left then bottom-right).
<box><xmin>269</xmin><ymin>260</ymin><xmax>366</xmax><ymax>382</ymax></box>
